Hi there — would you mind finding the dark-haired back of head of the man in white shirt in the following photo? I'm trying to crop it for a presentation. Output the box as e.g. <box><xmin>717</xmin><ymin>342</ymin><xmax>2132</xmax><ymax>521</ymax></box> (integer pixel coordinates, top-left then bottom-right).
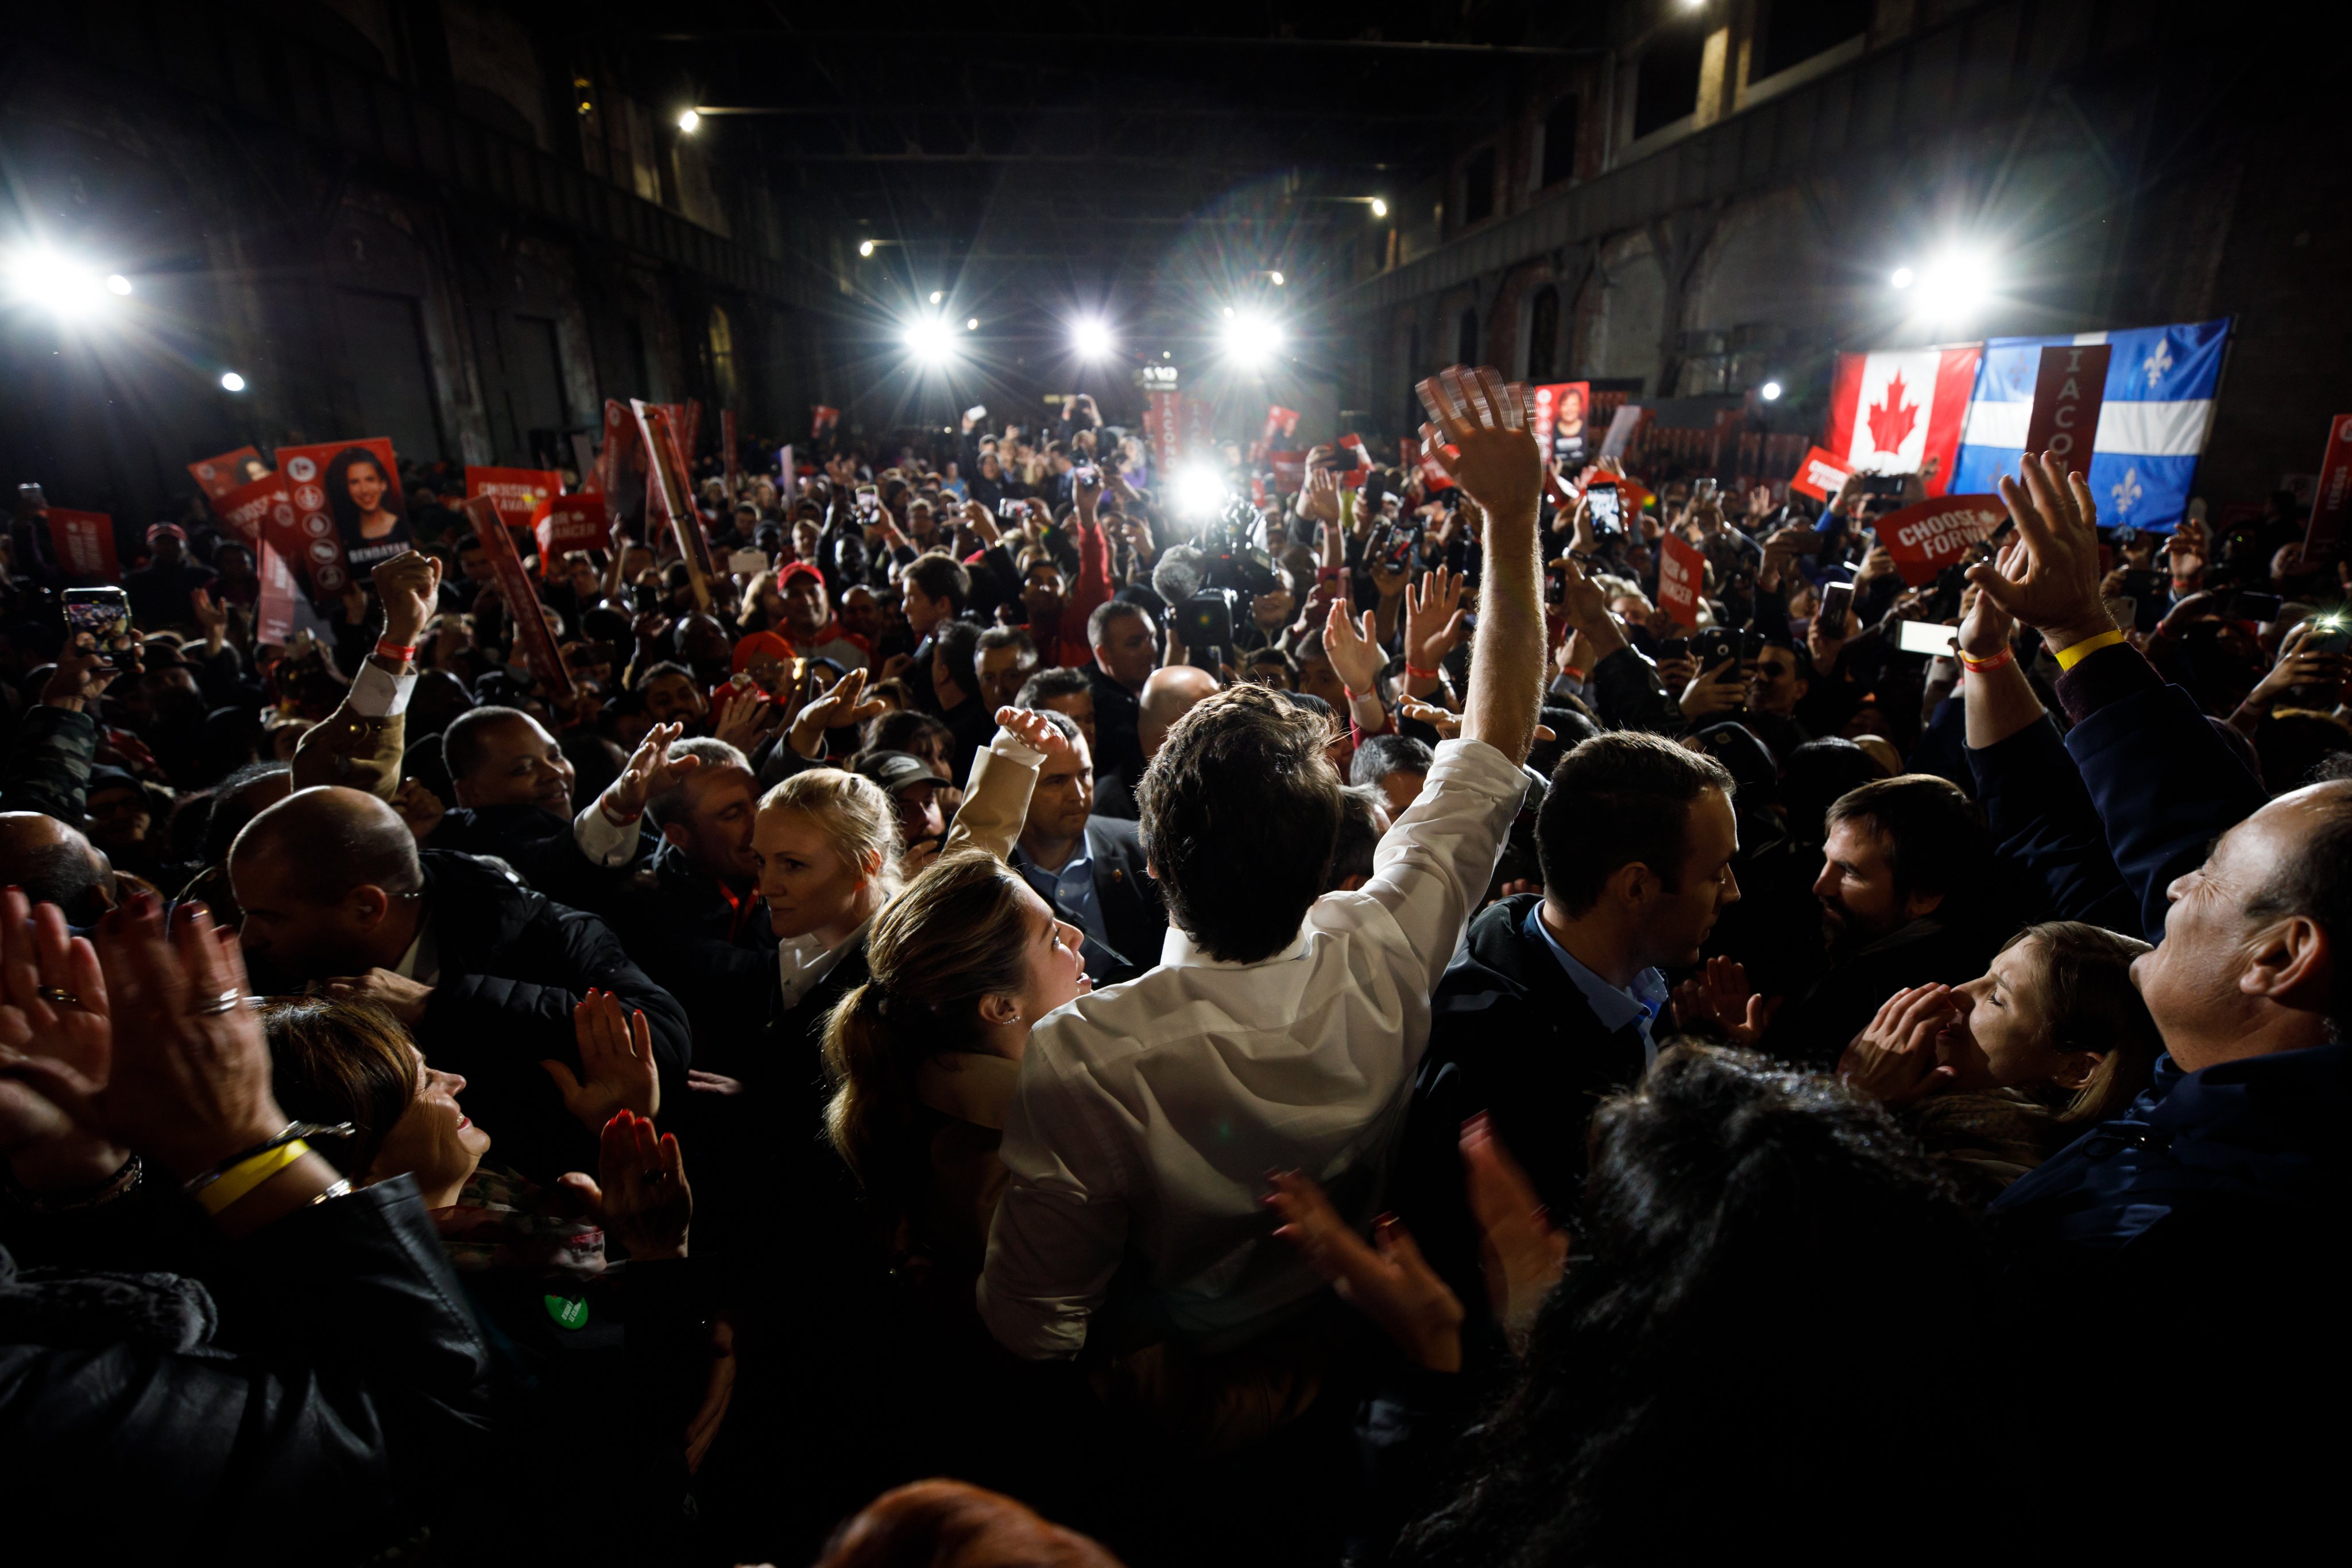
<box><xmin>1136</xmin><ymin>687</ymin><xmax>1341</xmax><ymax>964</ymax></box>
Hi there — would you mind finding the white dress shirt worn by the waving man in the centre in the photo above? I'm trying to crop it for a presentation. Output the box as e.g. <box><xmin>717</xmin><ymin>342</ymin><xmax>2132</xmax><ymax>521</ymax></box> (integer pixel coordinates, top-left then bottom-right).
<box><xmin>978</xmin><ymin>741</ymin><xmax>1526</xmax><ymax>1359</ymax></box>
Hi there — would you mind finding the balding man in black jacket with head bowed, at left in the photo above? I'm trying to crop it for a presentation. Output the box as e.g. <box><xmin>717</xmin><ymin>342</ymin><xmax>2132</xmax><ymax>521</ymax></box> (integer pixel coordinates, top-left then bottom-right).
<box><xmin>228</xmin><ymin>788</ymin><xmax>689</xmax><ymax>1180</ymax></box>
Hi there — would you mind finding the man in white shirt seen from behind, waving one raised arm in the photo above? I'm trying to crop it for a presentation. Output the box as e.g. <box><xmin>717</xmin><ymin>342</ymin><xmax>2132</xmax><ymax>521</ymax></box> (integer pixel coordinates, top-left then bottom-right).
<box><xmin>978</xmin><ymin>367</ymin><xmax>1545</xmax><ymax>1359</ymax></box>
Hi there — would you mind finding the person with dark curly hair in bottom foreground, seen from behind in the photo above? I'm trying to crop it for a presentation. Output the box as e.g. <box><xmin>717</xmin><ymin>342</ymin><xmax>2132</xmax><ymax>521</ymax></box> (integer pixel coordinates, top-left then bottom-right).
<box><xmin>1395</xmin><ymin>1046</ymin><xmax>2016</xmax><ymax>1568</ymax></box>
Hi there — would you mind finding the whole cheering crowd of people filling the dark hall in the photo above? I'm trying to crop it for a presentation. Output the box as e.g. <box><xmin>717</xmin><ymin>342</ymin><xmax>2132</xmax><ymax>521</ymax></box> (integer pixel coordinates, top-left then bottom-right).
<box><xmin>0</xmin><ymin>367</ymin><xmax>2352</xmax><ymax>1568</ymax></box>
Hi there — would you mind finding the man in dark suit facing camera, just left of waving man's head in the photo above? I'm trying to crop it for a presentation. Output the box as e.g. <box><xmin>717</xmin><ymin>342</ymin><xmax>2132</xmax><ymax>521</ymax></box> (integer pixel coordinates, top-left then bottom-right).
<box><xmin>1011</xmin><ymin>713</ymin><xmax>1169</xmax><ymax>985</ymax></box>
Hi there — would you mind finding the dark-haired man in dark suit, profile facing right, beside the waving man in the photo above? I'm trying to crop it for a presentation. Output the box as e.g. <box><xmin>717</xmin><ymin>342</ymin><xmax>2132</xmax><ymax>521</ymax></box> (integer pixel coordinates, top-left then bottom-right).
<box><xmin>1390</xmin><ymin>731</ymin><xmax>1740</xmax><ymax>1323</ymax></box>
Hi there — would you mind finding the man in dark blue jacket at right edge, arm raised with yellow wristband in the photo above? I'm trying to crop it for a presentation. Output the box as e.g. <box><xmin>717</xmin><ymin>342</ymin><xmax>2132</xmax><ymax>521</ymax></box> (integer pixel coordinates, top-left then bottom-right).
<box><xmin>1968</xmin><ymin>458</ymin><xmax>2352</xmax><ymax>1549</ymax></box>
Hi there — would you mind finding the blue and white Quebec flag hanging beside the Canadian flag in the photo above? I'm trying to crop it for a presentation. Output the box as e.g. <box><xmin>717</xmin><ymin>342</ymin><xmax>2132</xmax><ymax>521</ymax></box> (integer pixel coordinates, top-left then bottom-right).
<box><xmin>1950</xmin><ymin>318</ymin><xmax>2230</xmax><ymax>531</ymax></box>
